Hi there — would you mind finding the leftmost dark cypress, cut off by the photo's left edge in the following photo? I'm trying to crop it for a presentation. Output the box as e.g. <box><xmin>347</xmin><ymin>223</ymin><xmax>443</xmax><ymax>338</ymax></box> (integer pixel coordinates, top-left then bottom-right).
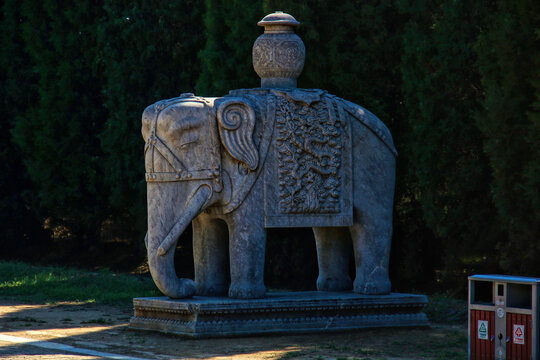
<box><xmin>0</xmin><ymin>0</ymin><xmax>46</xmax><ymax>258</ymax></box>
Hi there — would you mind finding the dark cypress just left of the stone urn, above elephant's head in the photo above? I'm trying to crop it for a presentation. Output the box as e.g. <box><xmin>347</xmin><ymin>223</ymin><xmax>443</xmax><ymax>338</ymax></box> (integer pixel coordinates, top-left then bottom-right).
<box><xmin>196</xmin><ymin>0</ymin><xmax>263</xmax><ymax>96</ymax></box>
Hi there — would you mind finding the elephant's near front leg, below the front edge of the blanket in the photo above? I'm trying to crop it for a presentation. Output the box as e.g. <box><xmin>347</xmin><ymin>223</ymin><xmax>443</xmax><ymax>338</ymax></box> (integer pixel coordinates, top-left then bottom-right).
<box><xmin>229</xmin><ymin>204</ymin><xmax>266</xmax><ymax>299</ymax></box>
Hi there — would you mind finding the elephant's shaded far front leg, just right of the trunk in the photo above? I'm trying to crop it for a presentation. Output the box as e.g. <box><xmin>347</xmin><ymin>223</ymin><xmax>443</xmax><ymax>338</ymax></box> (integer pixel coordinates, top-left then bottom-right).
<box><xmin>193</xmin><ymin>213</ymin><xmax>229</xmax><ymax>296</ymax></box>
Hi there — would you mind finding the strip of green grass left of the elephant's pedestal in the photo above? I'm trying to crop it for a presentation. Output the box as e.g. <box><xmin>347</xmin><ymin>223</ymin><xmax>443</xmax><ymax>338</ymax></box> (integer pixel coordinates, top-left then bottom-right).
<box><xmin>0</xmin><ymin>261</ymin><xmax>160</xmax><ymax>305</ymax></box>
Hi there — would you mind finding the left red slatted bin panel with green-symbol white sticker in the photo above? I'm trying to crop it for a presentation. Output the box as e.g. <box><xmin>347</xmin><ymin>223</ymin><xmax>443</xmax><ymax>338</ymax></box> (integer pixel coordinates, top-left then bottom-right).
<box><xmin>470</xmin><ymin>310</ymin><xmax>495</xmax><ymax>360</ymax></box>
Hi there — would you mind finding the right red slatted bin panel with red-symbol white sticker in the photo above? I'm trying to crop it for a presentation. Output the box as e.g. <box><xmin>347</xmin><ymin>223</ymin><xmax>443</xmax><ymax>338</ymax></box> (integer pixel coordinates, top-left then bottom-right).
<box><xmin>506</xmin><ymin>313</ymin><xmax>532</xmax><ymax>360</ymax></box>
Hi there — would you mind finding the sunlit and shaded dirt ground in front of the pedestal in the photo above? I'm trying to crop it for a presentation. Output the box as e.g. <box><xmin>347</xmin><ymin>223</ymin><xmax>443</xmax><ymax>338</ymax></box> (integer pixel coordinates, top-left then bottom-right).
<box><xmin>0</xmin><ymin>300</ymin><xmax>467</xmax><ymax>360</ymax></box>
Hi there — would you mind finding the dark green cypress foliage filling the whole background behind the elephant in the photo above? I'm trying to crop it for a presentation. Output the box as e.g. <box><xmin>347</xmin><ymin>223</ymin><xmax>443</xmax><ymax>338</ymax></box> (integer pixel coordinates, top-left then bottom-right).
<box><xmin>0</xmin><ymin>0</ymin><xmax>540</xmax><ymax>288</ymax></box>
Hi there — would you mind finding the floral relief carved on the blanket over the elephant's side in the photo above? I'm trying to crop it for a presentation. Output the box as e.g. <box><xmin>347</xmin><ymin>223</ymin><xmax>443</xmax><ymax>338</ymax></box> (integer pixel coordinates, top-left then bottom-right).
<box><xmin>276</xmin><ymin>96</ymin><xmax>344</xmax><ymax>214</ymax></box>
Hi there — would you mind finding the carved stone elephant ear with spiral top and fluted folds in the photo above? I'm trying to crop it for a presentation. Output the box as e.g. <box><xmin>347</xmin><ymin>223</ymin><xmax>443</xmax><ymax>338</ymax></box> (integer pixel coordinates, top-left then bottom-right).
<box><xmin>217</xmin><ymin>98</ymin><xmax>259</xmax><ymax>170</ymax></box>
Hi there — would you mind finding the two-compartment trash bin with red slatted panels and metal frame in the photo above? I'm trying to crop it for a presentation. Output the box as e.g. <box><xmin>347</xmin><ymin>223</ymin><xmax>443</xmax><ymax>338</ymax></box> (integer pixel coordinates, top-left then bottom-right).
<box><xmin>469</xmin><ymin>275</ymin><xmax>540</xmax><ymax>360</ymax></box>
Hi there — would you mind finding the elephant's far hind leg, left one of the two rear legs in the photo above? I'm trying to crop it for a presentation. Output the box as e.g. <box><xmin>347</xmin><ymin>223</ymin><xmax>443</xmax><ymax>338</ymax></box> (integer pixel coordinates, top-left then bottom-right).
<box><xmin>313</xmin><ymin>227</ymin><xmax>352</xmax><ymax>291</ymax></box>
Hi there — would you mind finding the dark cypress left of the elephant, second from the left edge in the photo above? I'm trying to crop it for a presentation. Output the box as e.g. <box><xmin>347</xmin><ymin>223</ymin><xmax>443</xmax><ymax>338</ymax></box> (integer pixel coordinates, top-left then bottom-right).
<box><xmin>13</xmin><ymin>0</ymin><xmax>104</xmax><ymax>257</ymax></box>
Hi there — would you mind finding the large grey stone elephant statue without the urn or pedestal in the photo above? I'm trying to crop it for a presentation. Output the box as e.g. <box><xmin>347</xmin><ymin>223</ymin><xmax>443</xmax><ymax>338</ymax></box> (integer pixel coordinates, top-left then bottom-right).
<box><xmin>142</xmin><ymin>88</ymin><xmax>397</xmax><ymax>299</ymax></box>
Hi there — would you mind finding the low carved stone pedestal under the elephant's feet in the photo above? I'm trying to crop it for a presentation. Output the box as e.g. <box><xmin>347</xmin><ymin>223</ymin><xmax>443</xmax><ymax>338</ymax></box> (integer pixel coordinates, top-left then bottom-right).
<box><xmin>130</xmin><ymin>291</ymin><xmax>429</xmax><ymax>338</ymax></box>
